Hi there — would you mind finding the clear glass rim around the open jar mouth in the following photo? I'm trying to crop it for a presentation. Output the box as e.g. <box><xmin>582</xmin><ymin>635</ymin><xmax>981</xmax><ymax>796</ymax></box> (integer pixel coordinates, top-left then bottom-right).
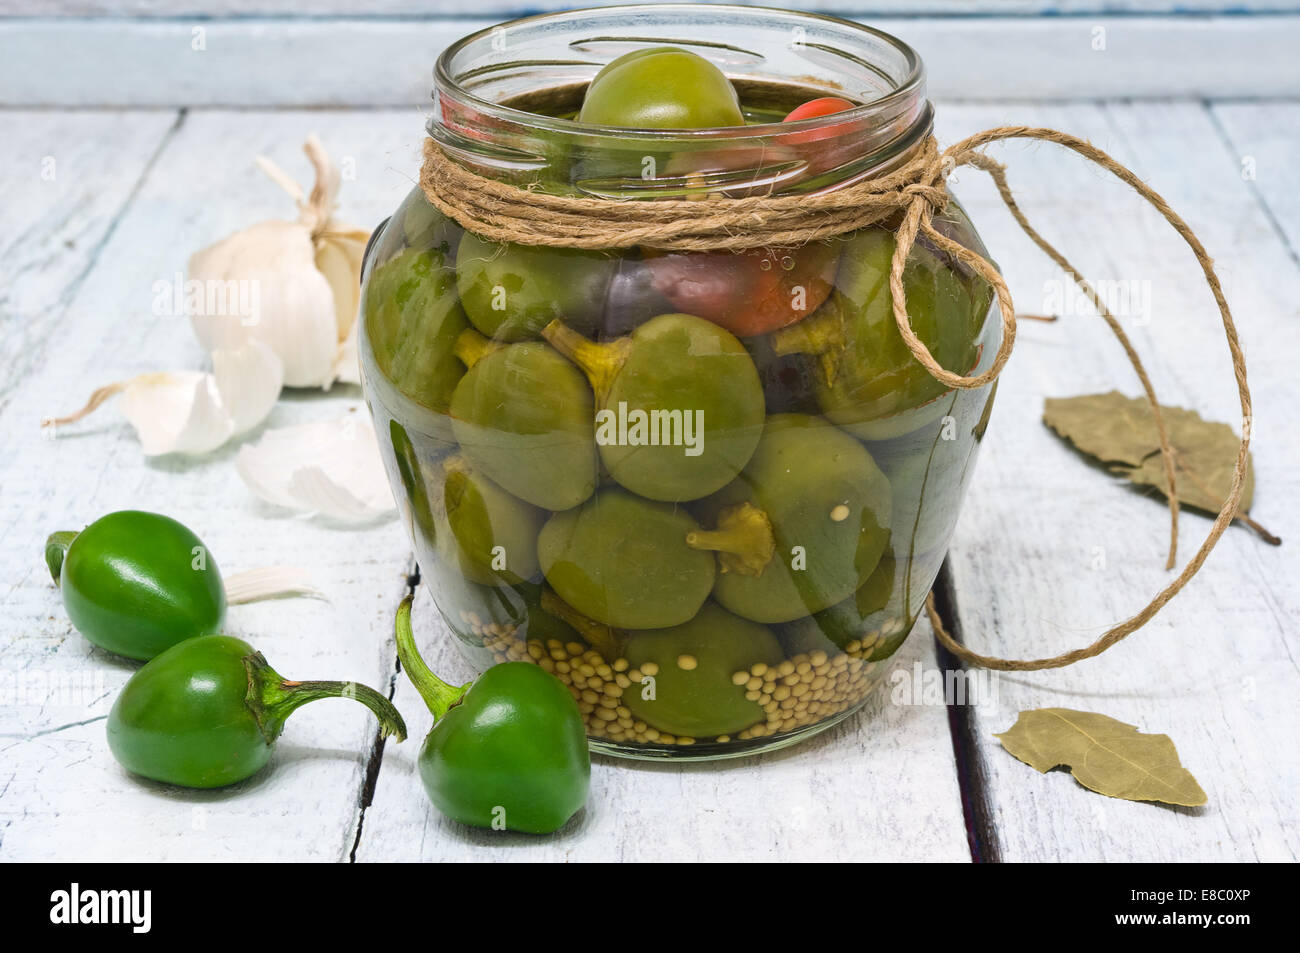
<box><xmin>433</xmin><ymin>3</ymin><xmax>931</xmax><ymax>140</ymax></box>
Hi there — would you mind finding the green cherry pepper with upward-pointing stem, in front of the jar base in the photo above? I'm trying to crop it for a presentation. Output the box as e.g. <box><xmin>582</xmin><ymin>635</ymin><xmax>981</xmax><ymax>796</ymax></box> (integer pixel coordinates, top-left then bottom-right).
<box><xmin>395</xmin><ymin>595</ymin><xmax>592</xmax><ymax>833</ymax></box>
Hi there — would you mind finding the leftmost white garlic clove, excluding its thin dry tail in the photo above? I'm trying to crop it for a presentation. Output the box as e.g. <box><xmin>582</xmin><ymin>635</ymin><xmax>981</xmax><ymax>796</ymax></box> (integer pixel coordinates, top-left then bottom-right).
<box><xmin>121</xmin><ymin>371</ymin><xmax>234</xmax><ymax>456</ymax></box>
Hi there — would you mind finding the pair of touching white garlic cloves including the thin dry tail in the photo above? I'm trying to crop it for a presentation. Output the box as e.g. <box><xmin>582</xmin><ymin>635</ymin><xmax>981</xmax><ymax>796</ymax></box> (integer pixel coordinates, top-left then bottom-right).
<box><xmin>42</xmin><ymin>341</ymin><xmax>283</xmax><ymax>456</ymax></box>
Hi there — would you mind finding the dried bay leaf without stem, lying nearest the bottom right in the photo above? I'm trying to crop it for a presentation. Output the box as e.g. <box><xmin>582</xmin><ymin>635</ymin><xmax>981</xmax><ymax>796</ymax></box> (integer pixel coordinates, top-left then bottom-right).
<box><xmin>995</xmin><ymin>709</ymin><xmax>1206</xmax><ymax>807</ymax></box>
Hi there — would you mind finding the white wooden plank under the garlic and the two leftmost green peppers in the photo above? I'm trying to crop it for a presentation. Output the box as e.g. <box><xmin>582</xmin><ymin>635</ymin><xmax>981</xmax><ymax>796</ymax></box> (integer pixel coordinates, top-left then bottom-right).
<box><xmin>0</xmin><ymin>111</ymin><xmax>431</xmax><ymax>861</ymax></box>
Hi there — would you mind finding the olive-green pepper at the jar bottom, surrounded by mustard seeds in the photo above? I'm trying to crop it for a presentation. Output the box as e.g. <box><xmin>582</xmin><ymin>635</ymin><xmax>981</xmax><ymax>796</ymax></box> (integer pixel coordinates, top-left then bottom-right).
<box><xmin>623</xmin><ymin>602</ymin><xmax>783</xmax><ymax>738</ymax></box>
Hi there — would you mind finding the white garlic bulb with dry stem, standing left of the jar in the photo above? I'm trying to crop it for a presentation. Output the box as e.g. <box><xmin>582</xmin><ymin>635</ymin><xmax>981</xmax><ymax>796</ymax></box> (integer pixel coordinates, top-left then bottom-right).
<box><xmin>189</xmin><ymin>135</ymin><xmax>369</xmax><ymax>389</ymax></box>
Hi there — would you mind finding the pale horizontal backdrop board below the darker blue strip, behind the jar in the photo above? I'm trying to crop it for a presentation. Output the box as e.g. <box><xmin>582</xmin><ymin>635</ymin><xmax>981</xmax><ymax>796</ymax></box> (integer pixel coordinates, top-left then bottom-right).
<box><xmin>0</xmin><ymin>14</ymin><xmax>1300</xmax><ymax>107</ymax></box>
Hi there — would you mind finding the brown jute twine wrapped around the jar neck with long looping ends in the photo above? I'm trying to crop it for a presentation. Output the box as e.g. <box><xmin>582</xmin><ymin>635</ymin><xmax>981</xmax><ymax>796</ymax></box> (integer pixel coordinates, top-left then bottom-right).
<box><xmin>420</xmin><ymin>126</ymin><xmax>1252</xmax><ymax>672</ymax></box>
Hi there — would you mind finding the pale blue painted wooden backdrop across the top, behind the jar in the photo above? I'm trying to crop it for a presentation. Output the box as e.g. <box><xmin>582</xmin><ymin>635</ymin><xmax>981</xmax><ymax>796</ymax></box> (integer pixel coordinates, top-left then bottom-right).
<box><xmin>0</xmin><ymin>0</ymin><xmax>1300</xmax><ymax>107</ymax></box>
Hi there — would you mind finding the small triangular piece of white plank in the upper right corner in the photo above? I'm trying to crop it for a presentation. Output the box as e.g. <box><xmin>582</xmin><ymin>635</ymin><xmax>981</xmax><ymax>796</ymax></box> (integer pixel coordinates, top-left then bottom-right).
<box><xmin>1210</xmin><ymin>103</ymin><xmax>1300</xmax><ymax>260</ymax></box>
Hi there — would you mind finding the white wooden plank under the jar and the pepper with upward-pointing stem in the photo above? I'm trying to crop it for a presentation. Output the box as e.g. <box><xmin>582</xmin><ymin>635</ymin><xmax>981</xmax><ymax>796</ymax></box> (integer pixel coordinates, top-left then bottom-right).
<box><xmin>356</xmin><ymin>586</ymin><xmax>970</xmax><ymax>863</ymax></box>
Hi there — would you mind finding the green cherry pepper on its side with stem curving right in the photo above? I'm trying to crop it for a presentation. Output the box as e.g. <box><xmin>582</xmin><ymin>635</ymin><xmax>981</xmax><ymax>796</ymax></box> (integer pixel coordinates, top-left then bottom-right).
<box><xmin>108</xmin><ymin>636</ymin><xmax>406</xmax><ymax>788</ymax></box>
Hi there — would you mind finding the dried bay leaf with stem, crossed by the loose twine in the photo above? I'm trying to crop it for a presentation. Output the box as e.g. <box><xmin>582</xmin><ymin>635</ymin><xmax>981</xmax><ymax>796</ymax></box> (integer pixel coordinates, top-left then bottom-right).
<box><xmin>1043</xmin><ymin>390</ymin><xmax>1282</xmax><ymax>545</ymax></box>
